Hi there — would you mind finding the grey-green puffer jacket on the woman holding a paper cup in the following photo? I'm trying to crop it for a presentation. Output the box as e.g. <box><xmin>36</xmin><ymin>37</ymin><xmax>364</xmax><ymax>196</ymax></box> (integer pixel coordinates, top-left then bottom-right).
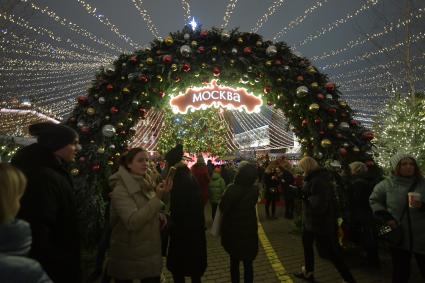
<box><xmin>369</xmin><ymin>176</ymin><xmax>425</xmax><ymax>254</ymax></box>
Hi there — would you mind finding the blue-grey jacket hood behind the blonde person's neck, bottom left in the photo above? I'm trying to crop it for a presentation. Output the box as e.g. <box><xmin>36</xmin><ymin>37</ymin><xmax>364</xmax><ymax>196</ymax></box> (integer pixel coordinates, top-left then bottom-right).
<box><xmin>0</xmin><ymin>219</ymin><xmax>32</xmax><ymax>256</ymax></box>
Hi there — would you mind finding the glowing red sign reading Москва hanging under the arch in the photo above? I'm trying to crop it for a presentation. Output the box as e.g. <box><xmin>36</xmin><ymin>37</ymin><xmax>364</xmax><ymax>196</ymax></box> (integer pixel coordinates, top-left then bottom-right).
<box><xmin>170</xmin><ymin>80</ymin><xmax>263</xmax><ymax>114</ymax></box>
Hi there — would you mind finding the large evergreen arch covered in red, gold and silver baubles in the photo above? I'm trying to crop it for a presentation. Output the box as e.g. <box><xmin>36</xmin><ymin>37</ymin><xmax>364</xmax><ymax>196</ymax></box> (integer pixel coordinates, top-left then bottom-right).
<box><xmin>68</xmin><ymin>27</ymin><xmax>373</xmax><ymax>247</ymax></box>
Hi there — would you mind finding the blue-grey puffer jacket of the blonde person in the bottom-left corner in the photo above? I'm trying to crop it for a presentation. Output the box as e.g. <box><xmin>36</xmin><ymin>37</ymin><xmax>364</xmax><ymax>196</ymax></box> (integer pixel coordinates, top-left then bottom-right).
<box><xmin>0</xmin><ymin>220</ymin><xmax>52</xmax><ymax>283</ymax></box>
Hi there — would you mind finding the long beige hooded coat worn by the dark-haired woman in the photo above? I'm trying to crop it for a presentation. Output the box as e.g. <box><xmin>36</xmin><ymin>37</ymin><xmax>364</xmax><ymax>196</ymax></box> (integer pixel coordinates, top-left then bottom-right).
<box><xmin>108</xmin><ymin>167</ymin><xmax>163</xmax><ymax>280</ymax></box>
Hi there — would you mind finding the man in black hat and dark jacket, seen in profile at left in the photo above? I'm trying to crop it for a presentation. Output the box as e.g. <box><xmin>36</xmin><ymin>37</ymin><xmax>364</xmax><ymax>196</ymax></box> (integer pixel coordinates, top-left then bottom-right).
<box><xmin>12</xmin><ymin>123</ymin><xmax>81</xmax><ymax>283</ymax></box>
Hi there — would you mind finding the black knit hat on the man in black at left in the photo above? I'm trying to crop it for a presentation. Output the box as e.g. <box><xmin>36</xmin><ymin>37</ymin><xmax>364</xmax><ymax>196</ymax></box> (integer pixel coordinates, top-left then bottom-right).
<box><xmin>28</xmin><ymin>122</ymin><xmax>78</xmax><ymax>152</ymax></box>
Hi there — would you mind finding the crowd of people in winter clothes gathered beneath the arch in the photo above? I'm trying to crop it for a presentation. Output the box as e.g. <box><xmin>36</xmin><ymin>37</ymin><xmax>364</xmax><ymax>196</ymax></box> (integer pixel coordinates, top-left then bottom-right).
<box><xmin>0</xmin><ymin>123</ymin><xmax>425</xmax><ymax>283</ymax></box>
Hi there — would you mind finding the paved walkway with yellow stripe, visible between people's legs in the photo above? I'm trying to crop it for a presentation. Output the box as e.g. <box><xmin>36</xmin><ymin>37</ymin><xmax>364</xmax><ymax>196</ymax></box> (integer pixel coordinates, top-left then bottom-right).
<box><xmin>157</xmin><ymin>204</ymin><xmax>423</xmax><ymax>283</ymax></box>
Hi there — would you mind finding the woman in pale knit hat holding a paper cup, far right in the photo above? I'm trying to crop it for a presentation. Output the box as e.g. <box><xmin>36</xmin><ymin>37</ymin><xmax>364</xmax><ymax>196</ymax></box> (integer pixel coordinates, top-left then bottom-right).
<box><xmin>369</xmin><ymin>153</ymin><xmax>425</xmax><ymax>282</ymax></box>
